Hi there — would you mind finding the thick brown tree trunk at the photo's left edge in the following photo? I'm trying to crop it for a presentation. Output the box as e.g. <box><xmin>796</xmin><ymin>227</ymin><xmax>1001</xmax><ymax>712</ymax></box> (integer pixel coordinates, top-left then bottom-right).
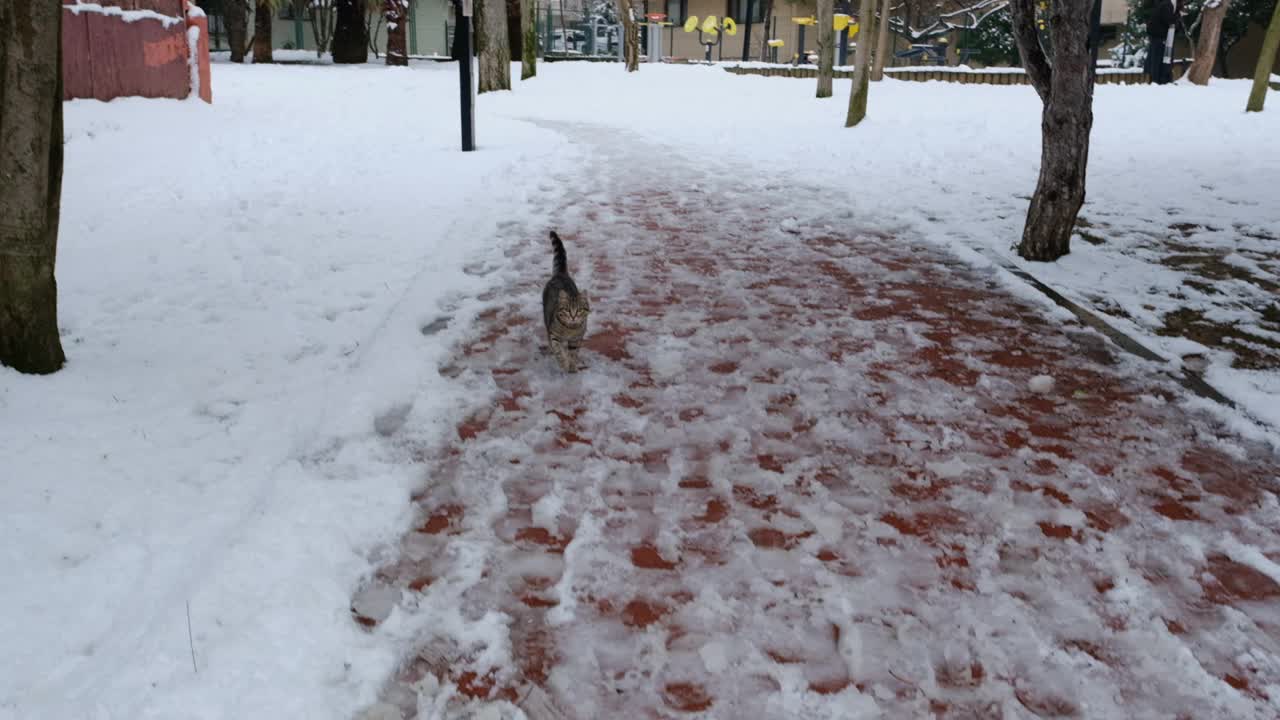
<box><xmin>0</xmin><ymin>0</ymin><xmax>67</xmax><ymax>374</ymax></box>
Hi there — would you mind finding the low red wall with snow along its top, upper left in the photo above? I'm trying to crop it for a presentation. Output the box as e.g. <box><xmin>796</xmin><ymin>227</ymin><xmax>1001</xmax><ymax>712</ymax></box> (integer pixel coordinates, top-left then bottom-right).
<box><xmin>63</xmin><ymin>0</ymin><xmax>212</xmax><ymax>102</ymax></box>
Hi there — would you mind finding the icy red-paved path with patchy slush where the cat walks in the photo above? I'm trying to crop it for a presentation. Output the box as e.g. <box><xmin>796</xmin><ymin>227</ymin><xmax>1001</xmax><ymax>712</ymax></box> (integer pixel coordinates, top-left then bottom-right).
<box><xmin>355</xmin><ymin>126</ymin><xmax>1280</xmax><ymax>720</ymax></box>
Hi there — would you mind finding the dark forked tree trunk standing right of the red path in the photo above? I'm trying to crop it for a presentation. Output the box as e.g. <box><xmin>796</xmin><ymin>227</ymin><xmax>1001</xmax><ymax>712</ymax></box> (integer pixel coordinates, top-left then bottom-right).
<box><xmin>1009</xmin><ymin>0</ymin><xmax>1093</xmax><ymax>261</ymax></box>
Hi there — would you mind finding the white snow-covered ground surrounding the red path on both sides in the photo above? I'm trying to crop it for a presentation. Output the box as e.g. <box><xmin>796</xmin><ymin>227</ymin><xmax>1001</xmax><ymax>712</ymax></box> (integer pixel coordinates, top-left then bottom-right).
<box><xmin>0</xmin><ymin>57</ymin><xmax>1280</xmax><ymax>720</ymax></box>
